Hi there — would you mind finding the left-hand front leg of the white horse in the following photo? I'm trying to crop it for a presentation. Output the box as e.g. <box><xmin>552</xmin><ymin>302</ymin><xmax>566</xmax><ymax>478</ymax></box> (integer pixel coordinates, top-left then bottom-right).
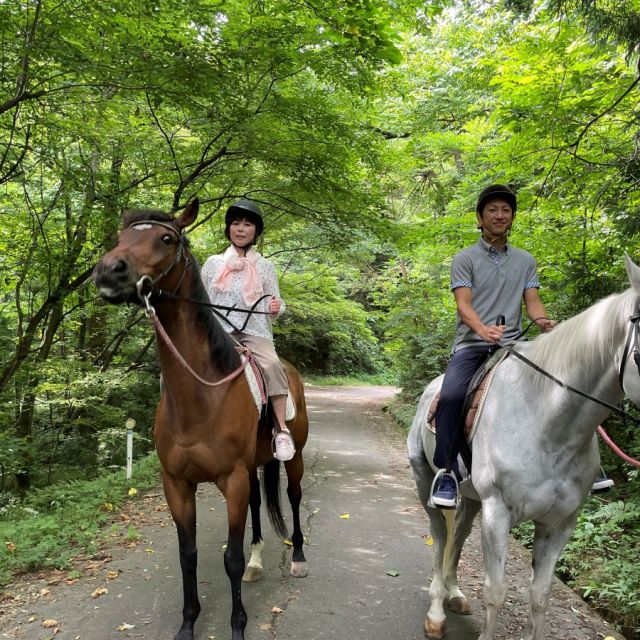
<box><xmin>478</xmin><ymin>498</ymin><xmax>511</xmax><ymax>640</ymax></box>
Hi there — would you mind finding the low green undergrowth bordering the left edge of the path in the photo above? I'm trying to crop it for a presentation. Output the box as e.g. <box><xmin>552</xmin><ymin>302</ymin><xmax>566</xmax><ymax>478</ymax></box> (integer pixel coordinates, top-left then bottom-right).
<box><xmin>0</xmin><ymin>453</ymin><xmax>160</xmax><ymax>586</ymax></box>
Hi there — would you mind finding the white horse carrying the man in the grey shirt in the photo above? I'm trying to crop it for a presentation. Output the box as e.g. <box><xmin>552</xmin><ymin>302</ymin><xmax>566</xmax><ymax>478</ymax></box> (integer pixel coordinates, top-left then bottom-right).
<box><xmin>408</xmin><ymin>257</ymin><xmax>640</xmax><ymax>640</ymax></box>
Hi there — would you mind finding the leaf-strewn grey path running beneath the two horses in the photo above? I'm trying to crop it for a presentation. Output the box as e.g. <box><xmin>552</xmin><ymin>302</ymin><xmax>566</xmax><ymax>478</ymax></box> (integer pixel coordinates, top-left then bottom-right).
<box><xmin>0</xmin><ymin>387</ymin><xmax>624</xmax><ymax>640</ymax></box>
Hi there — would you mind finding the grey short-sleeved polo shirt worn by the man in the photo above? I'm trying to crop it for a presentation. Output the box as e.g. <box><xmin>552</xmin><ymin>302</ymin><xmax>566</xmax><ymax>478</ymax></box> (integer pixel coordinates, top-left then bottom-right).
<box><xmin>451</xmin><ymin>238</ymin><xmax>540</xmax><ymax>351</ymax></box>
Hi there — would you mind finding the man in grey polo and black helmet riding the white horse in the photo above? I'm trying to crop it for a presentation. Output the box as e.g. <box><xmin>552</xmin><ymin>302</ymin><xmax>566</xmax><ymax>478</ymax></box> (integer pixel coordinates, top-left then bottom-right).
<box><xmin>433</xmin><ymin>184</ymin><xmax>556</xmax><ymax>507</ymax></box>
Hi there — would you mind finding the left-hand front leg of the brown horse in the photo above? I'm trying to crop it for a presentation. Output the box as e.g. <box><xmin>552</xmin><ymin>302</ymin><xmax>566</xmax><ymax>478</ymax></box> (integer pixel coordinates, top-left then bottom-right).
<box><xmin>162</xmin><ymin>472</ymin><xmax>200</xmax><ymax>640</ymax></box>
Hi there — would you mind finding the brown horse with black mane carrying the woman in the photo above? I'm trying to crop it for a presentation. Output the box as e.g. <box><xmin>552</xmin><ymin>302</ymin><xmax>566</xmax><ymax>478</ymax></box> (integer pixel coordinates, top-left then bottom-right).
<box><xmin>94</xmin><ymin>200</ymin><xmax>309</xmax><ymax>640</ymax></box>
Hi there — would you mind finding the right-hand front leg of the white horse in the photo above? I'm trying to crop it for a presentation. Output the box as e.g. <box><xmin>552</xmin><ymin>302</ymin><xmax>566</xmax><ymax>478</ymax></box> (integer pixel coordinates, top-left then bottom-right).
<box><xmin>525</xmin><ymin>511</ymin><xmax>578</xmax><ymax>640</ymax></box>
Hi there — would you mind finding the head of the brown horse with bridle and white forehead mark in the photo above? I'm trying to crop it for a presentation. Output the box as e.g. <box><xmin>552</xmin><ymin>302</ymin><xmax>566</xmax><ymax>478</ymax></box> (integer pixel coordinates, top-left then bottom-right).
<box><xmin>93</xmin><ymin>198</ymin><xmax>199</xmax><ymax>304</ymax></box>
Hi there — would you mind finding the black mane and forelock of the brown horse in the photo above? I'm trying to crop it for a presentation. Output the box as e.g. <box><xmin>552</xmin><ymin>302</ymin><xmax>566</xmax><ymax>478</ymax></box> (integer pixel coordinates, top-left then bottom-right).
<box><xmin>123</xmin><ymin>209</ymin><xmax>240</xmax><ymax>375</ymax></box>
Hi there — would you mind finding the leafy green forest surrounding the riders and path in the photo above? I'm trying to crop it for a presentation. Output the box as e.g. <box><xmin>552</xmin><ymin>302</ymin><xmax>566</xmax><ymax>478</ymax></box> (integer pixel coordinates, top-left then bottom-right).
<box><xmin>0</xmin><ymin>0</ymin><xmax>640</xmax><ymax>638</ymax></box>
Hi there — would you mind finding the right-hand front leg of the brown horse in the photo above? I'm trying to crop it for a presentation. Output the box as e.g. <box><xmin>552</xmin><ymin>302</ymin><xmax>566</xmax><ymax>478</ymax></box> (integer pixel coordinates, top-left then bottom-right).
<box><xmin>218</xmin><ymin>470</ymin><xmax>251</xmax><ymax>640</ymax></box>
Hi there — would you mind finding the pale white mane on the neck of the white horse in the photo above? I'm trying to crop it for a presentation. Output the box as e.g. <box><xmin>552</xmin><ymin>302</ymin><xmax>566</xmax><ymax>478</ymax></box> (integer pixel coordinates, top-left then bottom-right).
<box><xmin>518</xmin><ymin>289</ymin><xmax>638</xmax><ymax>384</ymax></box>
